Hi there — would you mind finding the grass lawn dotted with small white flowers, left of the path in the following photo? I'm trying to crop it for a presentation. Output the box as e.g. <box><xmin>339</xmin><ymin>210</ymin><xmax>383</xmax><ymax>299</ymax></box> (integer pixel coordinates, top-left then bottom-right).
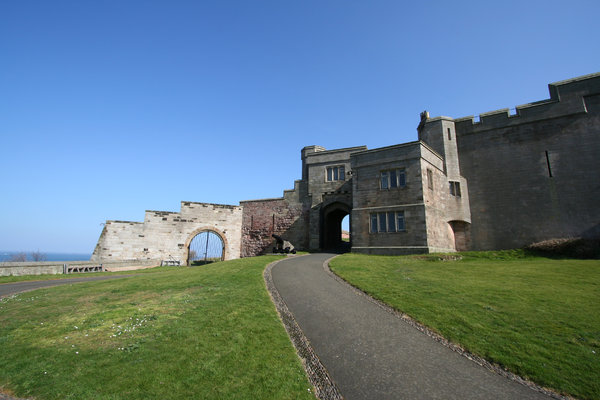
<box><xmin>0</xmin><ymin>256</ymin><xmax>314</xmax><ymax>400</ymax></box>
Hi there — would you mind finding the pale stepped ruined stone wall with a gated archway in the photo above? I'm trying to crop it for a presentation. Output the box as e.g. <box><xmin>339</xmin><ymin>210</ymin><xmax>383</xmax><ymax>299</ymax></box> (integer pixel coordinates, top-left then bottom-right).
<box><xmin>91</xmin><ymin>202</ymin><xmax>242</xmax><ymax>264</ymax></box>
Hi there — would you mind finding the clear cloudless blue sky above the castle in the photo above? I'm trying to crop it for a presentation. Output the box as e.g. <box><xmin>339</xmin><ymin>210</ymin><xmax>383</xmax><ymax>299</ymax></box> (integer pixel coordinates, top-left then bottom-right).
<box><xmin>0</xmin><ymin>0</ymin><xmax>600</xmax><ymax>253</ymax></box>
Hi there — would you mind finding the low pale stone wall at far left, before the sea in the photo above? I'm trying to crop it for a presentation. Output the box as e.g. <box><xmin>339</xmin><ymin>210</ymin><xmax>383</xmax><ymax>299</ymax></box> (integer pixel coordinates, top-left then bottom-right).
<box><xmin>0</xmin><ymin>260</ymin><xmax>160</xmax><ymax>276</ymax></box>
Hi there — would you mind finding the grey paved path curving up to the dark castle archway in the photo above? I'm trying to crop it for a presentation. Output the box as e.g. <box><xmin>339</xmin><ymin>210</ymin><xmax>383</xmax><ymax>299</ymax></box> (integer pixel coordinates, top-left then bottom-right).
<box><xmin>272</xmin><ymin>254</ymin><xmax>550</xmax><ymax>400</ymax></box>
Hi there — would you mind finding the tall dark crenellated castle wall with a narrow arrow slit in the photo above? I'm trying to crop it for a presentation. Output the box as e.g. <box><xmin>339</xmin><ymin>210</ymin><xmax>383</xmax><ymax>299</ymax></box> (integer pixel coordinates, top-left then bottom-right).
<box><xmin>454</xmin><ymin>74</ymin><xmax>600</xmax><ymax>250</ymax></box>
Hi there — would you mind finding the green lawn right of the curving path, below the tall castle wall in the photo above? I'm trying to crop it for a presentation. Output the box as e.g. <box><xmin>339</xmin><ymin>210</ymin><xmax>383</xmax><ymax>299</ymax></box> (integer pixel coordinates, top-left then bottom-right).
<box><xmin>331</xmin><ymin>250</ymin><xmax>600</xmax><ymax>399</ymax></box>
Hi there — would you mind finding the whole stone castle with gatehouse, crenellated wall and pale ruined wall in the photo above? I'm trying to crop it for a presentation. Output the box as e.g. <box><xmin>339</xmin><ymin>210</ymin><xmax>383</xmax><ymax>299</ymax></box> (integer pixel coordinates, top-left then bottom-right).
<box><xmin>92</xmin><ymin>73</ymin><xmax>600</xmax><ymax>263</ymax></box>
